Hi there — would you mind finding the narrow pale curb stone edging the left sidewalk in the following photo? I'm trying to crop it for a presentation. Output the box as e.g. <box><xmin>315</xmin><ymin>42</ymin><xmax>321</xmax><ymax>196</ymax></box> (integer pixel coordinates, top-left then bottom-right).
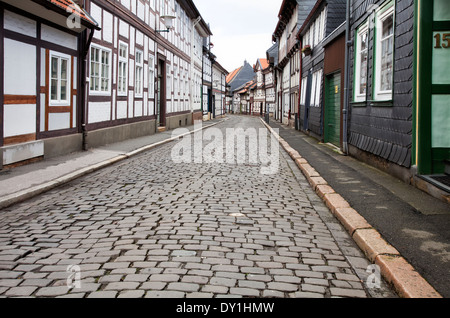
<box><xmin>0</xmin><ymin>118</ymin><xmax>229</xmax><ymax>209</ymax></box>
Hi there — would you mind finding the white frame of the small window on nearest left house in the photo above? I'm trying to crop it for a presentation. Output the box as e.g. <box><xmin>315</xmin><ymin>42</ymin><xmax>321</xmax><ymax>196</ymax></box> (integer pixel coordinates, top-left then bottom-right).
<box><xmin>48</xmin><ymin>51</ymin><xmax>72</xmax><ymax>106</ymax></box>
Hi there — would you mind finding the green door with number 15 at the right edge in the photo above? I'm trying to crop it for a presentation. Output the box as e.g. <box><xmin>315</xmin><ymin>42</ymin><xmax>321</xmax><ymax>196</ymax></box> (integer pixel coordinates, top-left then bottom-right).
<box><xmin>413</xmin><ymin>0</ymin><xmax>450</xmax><ymax>175</ymax></box>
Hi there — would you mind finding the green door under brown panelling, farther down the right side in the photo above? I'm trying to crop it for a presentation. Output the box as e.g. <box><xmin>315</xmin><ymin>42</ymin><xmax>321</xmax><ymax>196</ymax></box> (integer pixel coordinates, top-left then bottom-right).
<box><xmin>324</xmin><ymin>73</ymin><xmax>341</xmax><ymax>147</ymax></box>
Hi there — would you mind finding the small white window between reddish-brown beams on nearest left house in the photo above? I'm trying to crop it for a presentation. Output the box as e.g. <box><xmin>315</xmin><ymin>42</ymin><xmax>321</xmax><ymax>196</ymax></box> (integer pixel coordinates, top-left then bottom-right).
<box><xmin>50</xmin><ymin>52</ymin><xmax>71</xmax><ymax>105</ymax></box>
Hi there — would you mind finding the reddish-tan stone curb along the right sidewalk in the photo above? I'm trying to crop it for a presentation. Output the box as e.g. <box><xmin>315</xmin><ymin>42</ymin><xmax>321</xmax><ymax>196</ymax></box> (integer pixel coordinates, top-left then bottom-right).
<box><xmin>261</xmin><ymin>119</ymin><xmax>442</xmax><ymax>298</ymax></box>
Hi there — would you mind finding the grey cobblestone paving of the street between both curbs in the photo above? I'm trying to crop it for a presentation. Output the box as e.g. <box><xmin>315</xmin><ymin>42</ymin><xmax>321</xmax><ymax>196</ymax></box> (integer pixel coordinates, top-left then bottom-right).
<box><xmin>0</xmin><ymin>116</ymin><xmax>394</xmax><ymax>298</ymax></box>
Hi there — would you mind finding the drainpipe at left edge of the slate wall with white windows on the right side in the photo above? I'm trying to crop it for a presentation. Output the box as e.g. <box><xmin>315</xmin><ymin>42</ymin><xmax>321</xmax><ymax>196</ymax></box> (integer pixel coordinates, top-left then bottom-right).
<box><xmin>342</xmin><ymin>0</ymin><xmax>352</xmax><ymax>155</ymax></box>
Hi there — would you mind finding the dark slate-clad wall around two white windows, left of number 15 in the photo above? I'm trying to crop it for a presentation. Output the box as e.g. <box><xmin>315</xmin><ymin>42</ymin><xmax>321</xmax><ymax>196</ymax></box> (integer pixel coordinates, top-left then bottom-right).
<box><xmin>349</xmin><ymin>0</ymin><xmax>414</xmax><ymax>168</ymax></box>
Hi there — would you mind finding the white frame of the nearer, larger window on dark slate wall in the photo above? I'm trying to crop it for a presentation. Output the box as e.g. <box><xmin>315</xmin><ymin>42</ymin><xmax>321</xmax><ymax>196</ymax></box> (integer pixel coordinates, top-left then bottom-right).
<box><xmin>373</xmin><ymin>2</ymin><xmax>395</xmax><ymax>101</ymax></box>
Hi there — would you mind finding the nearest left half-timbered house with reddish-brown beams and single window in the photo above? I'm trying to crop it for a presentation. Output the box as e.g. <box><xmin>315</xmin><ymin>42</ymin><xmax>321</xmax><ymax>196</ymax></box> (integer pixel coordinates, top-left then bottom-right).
<box><xmin>0</xmin><ymin>0</ymin><xmax>99</xmax><ymax>166</ymax></box>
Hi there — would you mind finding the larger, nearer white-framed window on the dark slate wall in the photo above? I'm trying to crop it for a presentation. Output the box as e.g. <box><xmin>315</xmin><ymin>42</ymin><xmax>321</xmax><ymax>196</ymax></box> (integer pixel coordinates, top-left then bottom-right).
<box><xmin>374</xmin><ymin>5</ymin><xmax>394</xmax><ymax>100</ymax></box>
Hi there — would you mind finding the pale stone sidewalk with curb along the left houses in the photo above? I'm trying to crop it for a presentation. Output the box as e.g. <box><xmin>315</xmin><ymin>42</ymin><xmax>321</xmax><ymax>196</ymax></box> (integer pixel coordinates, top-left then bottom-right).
<box><xmin>0</xmin><ymin>118</ymin><xmax>226</xmax><ymax>208</ymax></box>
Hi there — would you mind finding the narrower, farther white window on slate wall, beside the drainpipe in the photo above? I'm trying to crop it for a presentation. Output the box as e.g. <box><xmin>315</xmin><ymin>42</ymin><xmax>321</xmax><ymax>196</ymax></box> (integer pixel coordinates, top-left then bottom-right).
<box><xmin>354</xmin><ymin>24</ymin><xmax>369</xmax><ymax>101</ymax></box>
